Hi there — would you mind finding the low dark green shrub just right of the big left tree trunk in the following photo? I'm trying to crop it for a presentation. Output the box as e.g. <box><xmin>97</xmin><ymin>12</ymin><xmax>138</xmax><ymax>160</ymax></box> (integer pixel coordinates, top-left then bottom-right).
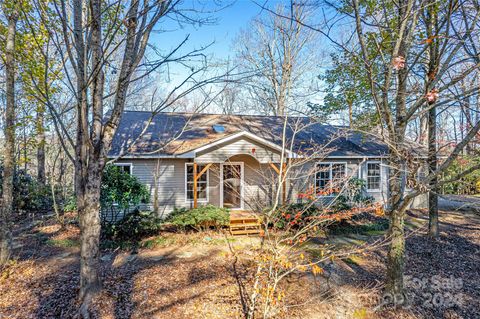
<box><xmin>102</xmin><ymin>209</ymin><xmax>161</xmax><ymax>242</ymax></box>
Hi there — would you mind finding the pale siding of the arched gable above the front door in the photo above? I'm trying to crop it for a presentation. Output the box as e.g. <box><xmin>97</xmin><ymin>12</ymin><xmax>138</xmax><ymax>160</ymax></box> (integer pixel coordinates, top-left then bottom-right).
<box><xmin>195</xmin><ymin>137</ymin><xmax>280</xmax><ymax>163</ymax></box>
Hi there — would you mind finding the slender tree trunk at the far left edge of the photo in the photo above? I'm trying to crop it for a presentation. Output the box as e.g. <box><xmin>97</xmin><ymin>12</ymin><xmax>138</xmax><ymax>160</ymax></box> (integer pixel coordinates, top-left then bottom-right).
<box><xmin>0</xmin><ymin>12</ymin><xmax>18</xmax><ymax>266</ymax></box>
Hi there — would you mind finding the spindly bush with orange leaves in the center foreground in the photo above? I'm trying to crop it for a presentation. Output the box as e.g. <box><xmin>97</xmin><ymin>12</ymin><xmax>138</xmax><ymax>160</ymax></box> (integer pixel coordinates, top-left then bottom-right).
<box><xmin>245</xmin><ymin>192</ymin><xmax>383</xmax><ymax>318</ymax></box>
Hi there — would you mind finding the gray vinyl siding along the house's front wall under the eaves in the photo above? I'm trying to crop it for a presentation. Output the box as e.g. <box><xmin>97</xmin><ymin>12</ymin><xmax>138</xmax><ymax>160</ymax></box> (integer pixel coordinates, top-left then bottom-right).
<box><xmin>118</xmin><ymin>155</ymin><xmax>425</xmax><ymax>217</ymax></box>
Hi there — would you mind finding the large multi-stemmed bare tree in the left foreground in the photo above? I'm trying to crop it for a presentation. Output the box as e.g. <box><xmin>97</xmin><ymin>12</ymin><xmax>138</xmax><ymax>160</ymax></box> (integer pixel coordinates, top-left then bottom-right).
<box><xmin>29</xmin><ymin>0</ymin><xmax>190</xmax><ymax>318</ymax></box>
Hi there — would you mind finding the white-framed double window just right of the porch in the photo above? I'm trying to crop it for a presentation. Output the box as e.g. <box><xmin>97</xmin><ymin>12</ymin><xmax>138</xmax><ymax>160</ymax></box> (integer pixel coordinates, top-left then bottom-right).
<box><xmin>315</xmin><ymin>163</ymin><xmax>347</xmax><ymax>195</ymax></box>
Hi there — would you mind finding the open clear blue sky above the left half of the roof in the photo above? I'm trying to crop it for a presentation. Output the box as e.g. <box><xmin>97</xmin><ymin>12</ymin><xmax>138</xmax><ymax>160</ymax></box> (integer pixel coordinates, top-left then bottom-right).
<box><xmin>142</xmin><ymin>0</ymin><xmax>338</xmax><ymax>119</ymax></box>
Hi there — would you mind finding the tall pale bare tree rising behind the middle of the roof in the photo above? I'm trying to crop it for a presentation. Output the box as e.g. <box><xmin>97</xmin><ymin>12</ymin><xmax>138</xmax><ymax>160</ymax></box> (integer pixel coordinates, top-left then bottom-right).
<box><xmin>236</xmin><ymin>3</ymin><xmax>318</xmax><ymax>116</ymax></box>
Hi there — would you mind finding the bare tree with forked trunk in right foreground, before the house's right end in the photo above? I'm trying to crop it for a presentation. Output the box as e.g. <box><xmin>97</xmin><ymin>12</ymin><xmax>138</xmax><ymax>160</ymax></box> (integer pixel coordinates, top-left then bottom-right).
<box><xmin>352</xmin><ymin>0</ymin><xmax>480</xmax><ymax>304</ymax></box>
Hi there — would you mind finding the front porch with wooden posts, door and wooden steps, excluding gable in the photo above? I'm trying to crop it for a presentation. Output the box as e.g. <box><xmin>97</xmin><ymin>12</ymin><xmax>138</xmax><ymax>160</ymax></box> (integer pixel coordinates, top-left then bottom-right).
<box><xmin>188</xmin><ymin>154</ymin><xmax>287</xmax><ymax>235</ymax></box>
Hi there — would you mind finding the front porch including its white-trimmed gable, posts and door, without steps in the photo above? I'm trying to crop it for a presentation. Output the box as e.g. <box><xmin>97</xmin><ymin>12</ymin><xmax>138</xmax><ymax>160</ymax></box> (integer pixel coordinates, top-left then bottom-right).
<box><xmin>187</xmin><ymin>132</ymin><xmax>290</xmax><ymax>211</ymax></box>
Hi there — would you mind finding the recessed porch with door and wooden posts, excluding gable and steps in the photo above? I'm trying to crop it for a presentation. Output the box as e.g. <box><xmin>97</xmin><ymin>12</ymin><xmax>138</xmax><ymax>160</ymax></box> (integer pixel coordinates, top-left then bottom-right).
<box><xmin>187</xmin><ymin>154</ymin><xmax>290</xmax><ymax>212</ymax></box>
